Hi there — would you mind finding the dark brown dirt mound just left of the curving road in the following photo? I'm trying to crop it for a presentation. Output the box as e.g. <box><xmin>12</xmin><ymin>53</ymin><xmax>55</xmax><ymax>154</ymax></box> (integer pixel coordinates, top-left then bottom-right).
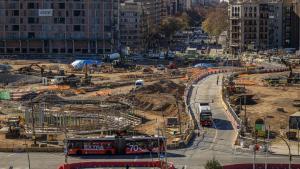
<box><xmin>136</xmin><ymin>80</ymin><xmax>184</xmax><ymax>96</ymax></box>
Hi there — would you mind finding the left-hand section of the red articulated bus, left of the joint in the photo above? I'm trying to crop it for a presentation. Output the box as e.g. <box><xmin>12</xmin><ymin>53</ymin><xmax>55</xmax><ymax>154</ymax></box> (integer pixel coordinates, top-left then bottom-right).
<box><xmin>66</xmin><ymin>137</ymin><xmax>116</xmax><ymax>155</ymax></box>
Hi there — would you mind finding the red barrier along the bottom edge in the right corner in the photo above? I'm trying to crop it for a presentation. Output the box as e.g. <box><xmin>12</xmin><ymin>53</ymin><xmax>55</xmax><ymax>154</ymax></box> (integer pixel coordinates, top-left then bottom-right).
<box><xmin>223</xmin><ymin>164</ymin><xmax>300</xmax><ymax>169</ymax></box>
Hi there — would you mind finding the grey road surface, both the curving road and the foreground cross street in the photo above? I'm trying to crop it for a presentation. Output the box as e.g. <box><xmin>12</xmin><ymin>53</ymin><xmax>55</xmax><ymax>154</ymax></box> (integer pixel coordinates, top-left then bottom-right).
<box><xmin>0</xmin><ymin>75</ymin><xmax>300</xmax><ymax>169</ymax></box>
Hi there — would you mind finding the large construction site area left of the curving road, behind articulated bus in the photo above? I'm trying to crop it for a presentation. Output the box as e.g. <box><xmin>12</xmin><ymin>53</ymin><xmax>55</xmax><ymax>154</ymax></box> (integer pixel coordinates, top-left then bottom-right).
<box><xmin>0</xmin><ymin>60</ymin><xmax>189</xmax><ymax>148</ymax></box>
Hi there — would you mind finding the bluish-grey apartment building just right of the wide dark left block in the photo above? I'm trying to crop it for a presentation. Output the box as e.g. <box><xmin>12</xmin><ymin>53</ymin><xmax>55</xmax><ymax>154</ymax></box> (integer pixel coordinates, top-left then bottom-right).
<box><xmin>120</xmin><ymin>0</ymin><xmax>163</xmax><ymax>52</ymax></box>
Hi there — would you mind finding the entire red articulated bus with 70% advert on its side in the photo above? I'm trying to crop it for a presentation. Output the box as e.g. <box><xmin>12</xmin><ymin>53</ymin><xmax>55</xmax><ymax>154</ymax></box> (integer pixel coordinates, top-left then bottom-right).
<box><xmin>65</xmin><ymin>136</ymin><xmax>166</xmax><ymax>155</ymax></box>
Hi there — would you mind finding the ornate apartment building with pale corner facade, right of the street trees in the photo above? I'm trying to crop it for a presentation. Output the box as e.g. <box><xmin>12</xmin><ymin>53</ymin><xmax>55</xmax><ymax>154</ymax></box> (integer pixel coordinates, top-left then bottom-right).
<box><xmin>229</xmin><ymin>0</ymin><xmax>283</xmax><ymax>53</ymax></box>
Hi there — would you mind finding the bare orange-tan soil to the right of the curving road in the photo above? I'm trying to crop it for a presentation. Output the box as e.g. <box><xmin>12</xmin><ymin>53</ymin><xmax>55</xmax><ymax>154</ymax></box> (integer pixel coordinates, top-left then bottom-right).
<box><xmin>237</xmin><ymin>73</ymin><xmax>300</xmax><ymax>133</ymax></box>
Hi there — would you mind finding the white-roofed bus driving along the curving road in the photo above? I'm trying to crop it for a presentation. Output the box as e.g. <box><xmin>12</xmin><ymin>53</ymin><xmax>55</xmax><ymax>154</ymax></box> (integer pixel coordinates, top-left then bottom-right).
<box><xmin>198</xmin><ymin>103</ymin><xmax>213</xmax><ymax>127</ymax></box>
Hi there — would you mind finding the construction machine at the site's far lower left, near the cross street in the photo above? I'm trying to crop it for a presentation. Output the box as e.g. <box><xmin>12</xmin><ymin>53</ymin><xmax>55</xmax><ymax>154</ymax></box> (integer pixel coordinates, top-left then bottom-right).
<box><xmin>5</xmin><ymin>117</ymin><xmax>21</xmax><ymax>139</ymax></box>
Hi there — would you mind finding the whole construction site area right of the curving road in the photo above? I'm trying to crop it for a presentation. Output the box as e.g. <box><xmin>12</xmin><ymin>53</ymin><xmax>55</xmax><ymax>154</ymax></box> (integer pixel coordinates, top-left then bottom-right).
<box><xmin>225</xmin><ymin>58</ymin><xmax>300</xmax><ymax>139</ymax></box>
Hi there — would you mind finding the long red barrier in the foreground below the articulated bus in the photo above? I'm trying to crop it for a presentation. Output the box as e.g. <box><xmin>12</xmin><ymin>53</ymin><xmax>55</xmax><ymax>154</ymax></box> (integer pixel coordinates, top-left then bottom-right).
<box><xmin>58</xmin><ymin>161</ymin><xmax>175</xmax><ymax>169</ymax></box>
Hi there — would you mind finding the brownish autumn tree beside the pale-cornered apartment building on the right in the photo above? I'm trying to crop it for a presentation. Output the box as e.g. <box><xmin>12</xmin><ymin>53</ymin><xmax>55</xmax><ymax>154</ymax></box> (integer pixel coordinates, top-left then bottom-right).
<box><xmin>202</xmin><ymin>4</ymin><xmax>228</xmax><ymax>40</ymax></box>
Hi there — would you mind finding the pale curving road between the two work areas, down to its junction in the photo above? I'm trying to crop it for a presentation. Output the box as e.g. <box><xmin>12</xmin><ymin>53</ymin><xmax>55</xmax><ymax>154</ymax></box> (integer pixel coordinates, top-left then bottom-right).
<box><xmin>166</xmin><ymin>75</ymin><xmax>236</xmax><ymax>168</ymax></box>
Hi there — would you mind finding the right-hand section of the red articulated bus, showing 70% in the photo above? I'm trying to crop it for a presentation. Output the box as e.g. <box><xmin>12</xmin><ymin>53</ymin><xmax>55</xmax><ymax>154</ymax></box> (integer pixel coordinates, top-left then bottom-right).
<box><xmin>125</xmin><ymin>137</ymin><xmax>166</xmax><ymax>154</ymax></box>
